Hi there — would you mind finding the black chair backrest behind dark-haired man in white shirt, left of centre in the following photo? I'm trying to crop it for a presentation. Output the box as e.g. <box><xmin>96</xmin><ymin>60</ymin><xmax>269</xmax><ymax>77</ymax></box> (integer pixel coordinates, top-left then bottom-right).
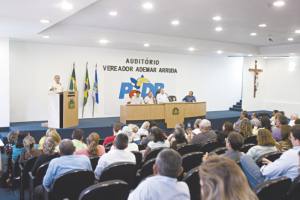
<box><xmin>99</xmin><ymin>162</ymin><xmax>137</xmax><ymax>188</ymax></box>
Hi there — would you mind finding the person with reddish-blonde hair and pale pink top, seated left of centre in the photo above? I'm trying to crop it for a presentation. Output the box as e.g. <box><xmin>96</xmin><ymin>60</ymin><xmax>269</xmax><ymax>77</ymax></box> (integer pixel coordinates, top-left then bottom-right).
<box><xmin>75</xmin><ymin>132</ymin><xmax>105</xmax><ymax>157</ymax></box>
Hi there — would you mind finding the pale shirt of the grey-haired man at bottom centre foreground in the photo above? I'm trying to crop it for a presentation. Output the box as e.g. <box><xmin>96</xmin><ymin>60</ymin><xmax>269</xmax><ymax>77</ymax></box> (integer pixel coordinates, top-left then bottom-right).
<box><xmin>128</xmin><ymin>175</ymin><xmax>190</xmax><ymax>200</ymax></box>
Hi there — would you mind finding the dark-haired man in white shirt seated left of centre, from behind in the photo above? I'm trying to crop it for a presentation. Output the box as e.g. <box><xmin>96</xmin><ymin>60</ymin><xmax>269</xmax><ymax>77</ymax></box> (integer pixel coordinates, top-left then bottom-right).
<box><xmin>95</xmin><ymin>133</ymin><xmax>136</xmax><ymax>179</ymax></box>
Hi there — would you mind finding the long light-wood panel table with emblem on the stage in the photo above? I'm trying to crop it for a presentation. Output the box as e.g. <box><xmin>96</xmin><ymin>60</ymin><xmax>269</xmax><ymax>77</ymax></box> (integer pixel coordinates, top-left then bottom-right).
<box><xmin>120</xmin><ymin>102</ymin><xmax>206</xmax><ymax>128</ymax></box>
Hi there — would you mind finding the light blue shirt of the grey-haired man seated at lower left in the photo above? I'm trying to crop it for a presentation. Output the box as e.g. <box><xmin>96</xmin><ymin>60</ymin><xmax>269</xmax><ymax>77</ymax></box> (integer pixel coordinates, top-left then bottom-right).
<box><xmin>43</xmin><ymin>155</ymin><xmax>93</xmax><ymax>189</ymax></box>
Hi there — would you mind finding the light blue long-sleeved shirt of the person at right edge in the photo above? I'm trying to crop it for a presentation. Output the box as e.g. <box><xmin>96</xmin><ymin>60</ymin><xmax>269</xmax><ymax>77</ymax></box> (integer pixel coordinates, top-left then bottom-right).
<box><xmin>260</xmin><ymin>146</ymin><xmax>300</xmax><ymax>180</ymax></box>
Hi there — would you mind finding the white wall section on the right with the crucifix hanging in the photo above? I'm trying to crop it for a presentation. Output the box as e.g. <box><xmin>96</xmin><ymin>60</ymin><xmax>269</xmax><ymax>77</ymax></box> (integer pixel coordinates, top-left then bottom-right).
<box><xmin>243</xmin><ymin>57</ymin><xmax>300</xmax><ymax>116</ymax></box>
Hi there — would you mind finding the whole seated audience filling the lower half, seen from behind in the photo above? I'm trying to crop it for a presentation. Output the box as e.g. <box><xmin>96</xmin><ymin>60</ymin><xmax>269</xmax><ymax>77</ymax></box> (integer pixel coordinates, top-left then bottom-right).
<box><xmin>0</xmin><ymin>111</ymin><xmax>300</xmax><ymax>200</ymax></box>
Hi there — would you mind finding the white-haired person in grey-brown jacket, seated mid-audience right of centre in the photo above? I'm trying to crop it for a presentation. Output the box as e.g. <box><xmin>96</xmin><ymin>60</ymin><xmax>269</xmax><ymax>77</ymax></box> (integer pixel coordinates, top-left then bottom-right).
<box><xmin>191</xmin><ymin>119</ymin><xmax>217</xmax><ymax>146</ymax></box>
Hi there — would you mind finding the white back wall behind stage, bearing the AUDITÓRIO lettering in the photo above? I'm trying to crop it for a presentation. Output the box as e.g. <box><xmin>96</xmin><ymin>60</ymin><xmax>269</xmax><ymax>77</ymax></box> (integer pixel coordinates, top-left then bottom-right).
<box><xmin>10</xmin><ymin>41</ymin><xmax>243</xmax><ymax>122</ymax></box>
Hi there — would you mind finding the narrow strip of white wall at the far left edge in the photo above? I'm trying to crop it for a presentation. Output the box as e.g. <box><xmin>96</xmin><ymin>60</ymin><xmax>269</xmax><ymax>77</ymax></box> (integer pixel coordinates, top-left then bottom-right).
<box><xmin>0</xmin><ymin>38</ymin><xmax>9</xmax><ymax>127</ymax></box>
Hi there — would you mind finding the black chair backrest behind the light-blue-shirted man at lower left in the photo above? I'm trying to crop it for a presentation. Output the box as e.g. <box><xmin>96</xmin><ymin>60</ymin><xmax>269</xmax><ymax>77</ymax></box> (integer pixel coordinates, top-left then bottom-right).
<box><xmin>50</xmin><ymin>170</ymin><xmax>95</xmax><ymax>200</ymax></box>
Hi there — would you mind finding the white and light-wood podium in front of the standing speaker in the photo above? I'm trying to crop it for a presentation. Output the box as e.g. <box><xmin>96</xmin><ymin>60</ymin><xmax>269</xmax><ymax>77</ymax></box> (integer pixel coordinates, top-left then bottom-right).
<box><xmin>48</xmin><ymin>91</ymin><xmax>79</xmax><ymax>128</ymax></box>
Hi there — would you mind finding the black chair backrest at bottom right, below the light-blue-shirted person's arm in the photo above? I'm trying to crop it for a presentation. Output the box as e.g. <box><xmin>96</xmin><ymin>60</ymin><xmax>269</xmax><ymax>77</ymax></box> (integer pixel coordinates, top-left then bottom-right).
<box><xmin>255</xmin><ymin>177</ymin><xmax>292</xmax><ymax>200</ymax></box>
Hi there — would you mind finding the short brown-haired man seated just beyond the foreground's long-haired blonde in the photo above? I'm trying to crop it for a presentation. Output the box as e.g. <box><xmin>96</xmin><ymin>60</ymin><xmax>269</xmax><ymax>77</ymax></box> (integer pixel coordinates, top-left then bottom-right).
<box><xmin>222</xmin><ymin>131</ymin><xmax>244</xmax><ymax>162</ymax></box>
